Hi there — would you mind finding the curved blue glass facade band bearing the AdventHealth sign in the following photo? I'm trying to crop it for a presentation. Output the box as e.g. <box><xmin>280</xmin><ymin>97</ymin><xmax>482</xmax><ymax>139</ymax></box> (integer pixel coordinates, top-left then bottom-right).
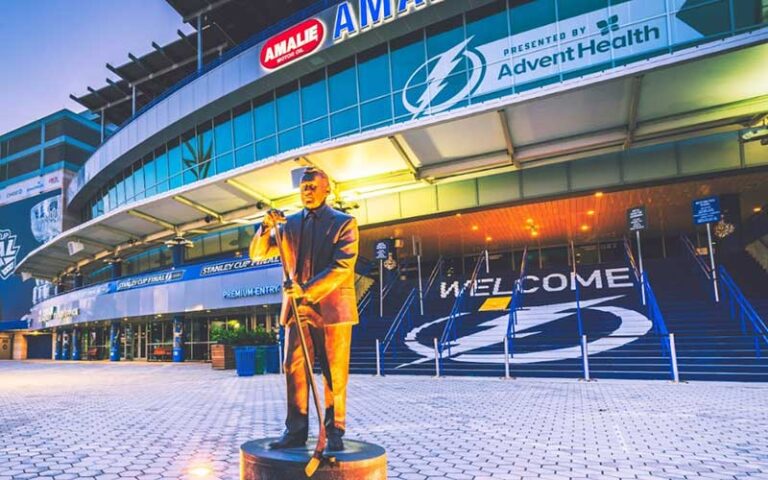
<box><xmin>83</xmin><ymin>0</ymin><xmax>766</xmax><ymax>220</ymax></box>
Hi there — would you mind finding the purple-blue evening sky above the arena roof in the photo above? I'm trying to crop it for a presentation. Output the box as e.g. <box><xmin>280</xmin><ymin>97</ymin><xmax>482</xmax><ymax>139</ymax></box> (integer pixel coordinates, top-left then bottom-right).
<box><xmin>0</xmin><ymin>0</ymin><xmax>193</xmax><ymax>135</ymax></box>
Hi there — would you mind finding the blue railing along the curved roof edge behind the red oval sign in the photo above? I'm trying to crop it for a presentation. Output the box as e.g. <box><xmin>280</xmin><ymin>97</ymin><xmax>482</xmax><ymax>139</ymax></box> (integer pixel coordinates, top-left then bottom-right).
<box><xmin>111</xmin><ymin>0</ymin><xmax>342</xmax><ymax>135</ymax></box>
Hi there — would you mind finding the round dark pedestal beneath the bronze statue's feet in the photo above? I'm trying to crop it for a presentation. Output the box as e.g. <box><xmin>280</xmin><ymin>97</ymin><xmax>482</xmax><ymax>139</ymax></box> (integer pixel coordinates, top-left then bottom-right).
<box><xmin>240</xmin><ymin>438</ymin><xmax>387</xmax><ymax>480</ymax></box>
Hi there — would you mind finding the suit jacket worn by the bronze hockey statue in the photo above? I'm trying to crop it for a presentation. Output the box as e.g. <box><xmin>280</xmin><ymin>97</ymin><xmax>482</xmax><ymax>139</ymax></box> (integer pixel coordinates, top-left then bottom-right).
<box><xmin>249</xmin><ymin>205</ymin><xmax>359</xmax><ymax>326</ymax></box>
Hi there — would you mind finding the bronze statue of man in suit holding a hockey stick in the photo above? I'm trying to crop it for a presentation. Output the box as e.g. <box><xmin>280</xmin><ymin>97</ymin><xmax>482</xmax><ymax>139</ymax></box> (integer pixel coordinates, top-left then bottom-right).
<box><xmin>250</xmin><ymin>168</ymin><xmax>359</xmax><ymax>451</ymax></box>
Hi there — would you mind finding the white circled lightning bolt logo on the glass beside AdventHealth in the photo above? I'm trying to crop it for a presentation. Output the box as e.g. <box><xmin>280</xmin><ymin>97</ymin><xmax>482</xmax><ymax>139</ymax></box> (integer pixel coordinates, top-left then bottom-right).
<box><xmin>403</xmin><ymin>37</ymin><xmax>485</xmax><ymax>118</ymax></box>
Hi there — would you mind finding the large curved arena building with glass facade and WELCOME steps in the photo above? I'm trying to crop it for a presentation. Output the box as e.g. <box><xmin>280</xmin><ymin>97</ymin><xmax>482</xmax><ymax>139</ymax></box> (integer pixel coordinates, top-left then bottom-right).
<box><xmin>3</xmin><ymin>0</ymin><xmax>768</xmax><ymax>376</ymax></box>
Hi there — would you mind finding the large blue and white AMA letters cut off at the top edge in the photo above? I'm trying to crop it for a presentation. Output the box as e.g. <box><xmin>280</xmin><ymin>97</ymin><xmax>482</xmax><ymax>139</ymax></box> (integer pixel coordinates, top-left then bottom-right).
<box><xmin>333</xmin><ymin>0</ymin><xmax>443</xmax><ymax>43</ymax></box>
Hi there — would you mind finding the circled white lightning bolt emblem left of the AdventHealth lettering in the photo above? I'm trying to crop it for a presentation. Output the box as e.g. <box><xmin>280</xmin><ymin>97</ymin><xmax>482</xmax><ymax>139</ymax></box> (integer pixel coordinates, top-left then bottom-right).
<box><xmin>403</xmin><ymin>37</ymin><xmax>485</xmax><ymax>118</ymax></box>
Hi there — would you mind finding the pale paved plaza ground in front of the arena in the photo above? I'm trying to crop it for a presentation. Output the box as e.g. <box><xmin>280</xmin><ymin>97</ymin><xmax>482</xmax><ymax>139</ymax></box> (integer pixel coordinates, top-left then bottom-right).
<box><xmin>0</xmin><ymin>361</ymin><xmax>768</xmax><ymax>480</ymax></box>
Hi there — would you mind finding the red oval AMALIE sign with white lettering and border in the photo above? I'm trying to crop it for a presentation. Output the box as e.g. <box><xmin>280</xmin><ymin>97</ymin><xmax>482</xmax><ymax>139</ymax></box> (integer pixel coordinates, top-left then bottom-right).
<box><xmin>261</xmin><ymin>18</ymin><xmax>325</xmax><ymax>70</ymax></box>
